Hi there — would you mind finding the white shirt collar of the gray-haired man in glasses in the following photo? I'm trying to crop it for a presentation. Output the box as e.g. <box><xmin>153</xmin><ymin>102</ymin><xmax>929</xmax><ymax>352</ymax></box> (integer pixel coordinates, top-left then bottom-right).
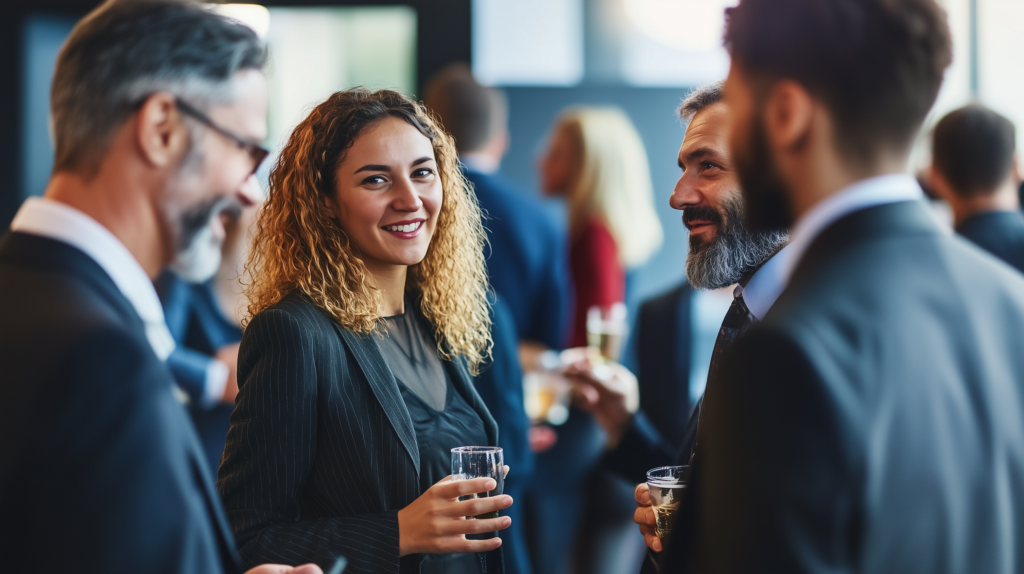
<box><xmin>10</xmin><ymin>197</ymin><xmax>174</xmax><ymax>360</ymax></box>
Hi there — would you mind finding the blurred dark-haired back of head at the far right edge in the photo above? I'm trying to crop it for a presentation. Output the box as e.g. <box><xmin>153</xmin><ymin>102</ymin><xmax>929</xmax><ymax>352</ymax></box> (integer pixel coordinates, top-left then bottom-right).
<box><xmin>932</xmin><ymin>105</ymin><xmax>1017</xmax><ymax>197</ymax></box>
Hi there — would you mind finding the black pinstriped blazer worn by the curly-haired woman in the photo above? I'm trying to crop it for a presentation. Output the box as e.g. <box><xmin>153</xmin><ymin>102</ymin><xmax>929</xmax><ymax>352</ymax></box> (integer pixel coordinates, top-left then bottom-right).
<box><xmin>217</xmin><ymin>294</ymin><xmax>501</xmax><ymax>573</ymax></box>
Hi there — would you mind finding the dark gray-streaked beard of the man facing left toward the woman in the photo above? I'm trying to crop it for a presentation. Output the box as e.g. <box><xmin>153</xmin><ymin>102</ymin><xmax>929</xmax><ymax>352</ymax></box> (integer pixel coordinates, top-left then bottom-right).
<box><xmin>683</xmin><ymin>194</ymin><xmax>790</xmax><ymax>290</ymax></box>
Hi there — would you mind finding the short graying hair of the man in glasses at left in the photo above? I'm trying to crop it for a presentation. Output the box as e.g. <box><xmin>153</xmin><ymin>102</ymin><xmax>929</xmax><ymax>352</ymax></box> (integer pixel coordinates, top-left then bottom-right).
<box><xmin>50</xmin><ymin>0</ymin><xmax>266</xmax><ymax>173</ymax></box>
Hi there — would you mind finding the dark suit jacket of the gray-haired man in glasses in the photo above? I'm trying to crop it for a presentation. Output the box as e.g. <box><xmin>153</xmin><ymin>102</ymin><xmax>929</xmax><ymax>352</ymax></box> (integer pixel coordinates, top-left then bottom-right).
<box><xmin>0</xmin><ymin>233</ymin><xmax>239</xmax><ymax>574</ymax></box>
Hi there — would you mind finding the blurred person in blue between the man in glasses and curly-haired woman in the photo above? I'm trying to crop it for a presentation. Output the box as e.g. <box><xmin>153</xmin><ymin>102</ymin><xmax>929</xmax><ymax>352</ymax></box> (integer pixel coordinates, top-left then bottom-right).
<box><xmin>156</xmin><ymin>184</ymin><xmax>262</xmax><ymax>478</ymax></box>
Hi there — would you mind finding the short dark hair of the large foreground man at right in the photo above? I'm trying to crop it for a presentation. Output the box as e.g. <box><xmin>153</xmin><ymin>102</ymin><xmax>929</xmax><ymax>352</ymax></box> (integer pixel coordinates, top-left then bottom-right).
<box><xmin>725</xmin><ymin>0</ymin><xmax>952</xmax><ymax>163</ymax></box>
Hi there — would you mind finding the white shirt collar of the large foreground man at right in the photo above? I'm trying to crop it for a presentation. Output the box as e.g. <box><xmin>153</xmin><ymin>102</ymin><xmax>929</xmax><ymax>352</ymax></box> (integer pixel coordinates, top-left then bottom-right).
<box><xmin>779</xmin><ymin>174</ymin><xmax>925</xmax><ymax>286</ymax></box>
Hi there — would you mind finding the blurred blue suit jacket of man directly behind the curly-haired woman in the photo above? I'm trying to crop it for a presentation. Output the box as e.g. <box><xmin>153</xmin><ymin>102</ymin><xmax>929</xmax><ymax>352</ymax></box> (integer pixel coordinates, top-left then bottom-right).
<box><xmin>465</xmin><ymin>170</ymin><xmax>570</xmax><ymax>349</ymax></box>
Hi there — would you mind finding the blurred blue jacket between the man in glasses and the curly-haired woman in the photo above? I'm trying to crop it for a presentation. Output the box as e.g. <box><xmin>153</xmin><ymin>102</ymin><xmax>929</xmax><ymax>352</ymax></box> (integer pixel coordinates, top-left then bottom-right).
<box><xmin>156</xmin><ymin>271</ymin><xmax>242</xmax><ymax>478</ymax></box>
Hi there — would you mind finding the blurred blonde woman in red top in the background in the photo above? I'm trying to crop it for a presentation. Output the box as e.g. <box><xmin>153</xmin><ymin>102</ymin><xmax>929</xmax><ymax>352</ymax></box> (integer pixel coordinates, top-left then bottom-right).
<box><xmin>528</xmin><ymin>107</ymin><xmax>662</xmax><ymax>573</ymax></box>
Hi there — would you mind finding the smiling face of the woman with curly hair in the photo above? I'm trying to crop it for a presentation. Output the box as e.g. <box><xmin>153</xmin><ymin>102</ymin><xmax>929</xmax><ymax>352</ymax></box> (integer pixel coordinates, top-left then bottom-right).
<box><xmin>332</xmin><ymin>118</ymin><xmax>443</xmax><ymax>274</ymax></box>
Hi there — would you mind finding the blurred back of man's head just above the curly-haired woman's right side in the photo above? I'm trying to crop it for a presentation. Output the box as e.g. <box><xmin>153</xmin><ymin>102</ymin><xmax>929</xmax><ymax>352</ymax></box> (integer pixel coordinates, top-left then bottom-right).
<box><xmin>423</xmin><ymin>63</ymin><xmax>508</xmax><ymax>153</ymax></box>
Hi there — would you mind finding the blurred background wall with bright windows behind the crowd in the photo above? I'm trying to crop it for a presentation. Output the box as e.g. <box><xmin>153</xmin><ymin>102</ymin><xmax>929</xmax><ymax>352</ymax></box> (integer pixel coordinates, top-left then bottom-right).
<box><xmin>6</xmin><ymin>0</ymin><xmax>1024</xmax><ymax>313</ymax></box>
